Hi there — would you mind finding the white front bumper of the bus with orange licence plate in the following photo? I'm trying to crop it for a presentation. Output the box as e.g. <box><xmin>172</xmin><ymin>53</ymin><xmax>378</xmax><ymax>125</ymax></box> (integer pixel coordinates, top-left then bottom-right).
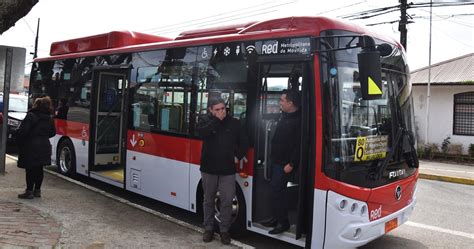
<box><xmin>324</xmin><ymin>191</ymin><xmax>416</xmax><ymax>248</ymax></box>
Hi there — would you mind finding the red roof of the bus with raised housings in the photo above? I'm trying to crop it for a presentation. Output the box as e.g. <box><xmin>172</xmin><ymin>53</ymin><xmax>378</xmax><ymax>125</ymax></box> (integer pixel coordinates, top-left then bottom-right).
<box><xmin>35</xmin><ymin>17</ymin><xmax>401</xmax><ymax>62</ymax></box>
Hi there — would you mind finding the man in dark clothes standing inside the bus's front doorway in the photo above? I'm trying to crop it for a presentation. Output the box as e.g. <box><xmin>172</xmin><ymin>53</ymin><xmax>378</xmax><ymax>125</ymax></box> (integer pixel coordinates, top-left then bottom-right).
<box><xmin>263</xmin><ymin>90</ymin><xmax>301</xmax><ymax>234</ymax></box>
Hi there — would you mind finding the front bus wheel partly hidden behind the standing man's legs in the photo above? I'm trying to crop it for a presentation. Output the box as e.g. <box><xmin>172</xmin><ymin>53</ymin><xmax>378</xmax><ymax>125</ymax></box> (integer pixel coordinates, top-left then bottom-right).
<box><xmin>214</xmin><ymin>185</ymin><xmax>247</xmax><ymax>237</ymax></box>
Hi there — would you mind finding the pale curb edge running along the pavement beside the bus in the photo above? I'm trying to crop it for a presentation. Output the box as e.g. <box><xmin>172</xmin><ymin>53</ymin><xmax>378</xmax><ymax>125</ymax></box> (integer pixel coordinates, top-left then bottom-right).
<box><xmin>6</xmin><ymin>154</ymin><xmax>255</xmax><ymax>249</ymax></box>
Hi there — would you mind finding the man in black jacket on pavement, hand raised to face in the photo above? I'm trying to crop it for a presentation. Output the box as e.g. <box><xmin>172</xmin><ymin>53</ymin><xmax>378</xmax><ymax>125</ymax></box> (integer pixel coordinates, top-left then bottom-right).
<box><xmin>196</xmin><ymin>98</ymin><xmax>248</xmax><ymax>244</ymax></box>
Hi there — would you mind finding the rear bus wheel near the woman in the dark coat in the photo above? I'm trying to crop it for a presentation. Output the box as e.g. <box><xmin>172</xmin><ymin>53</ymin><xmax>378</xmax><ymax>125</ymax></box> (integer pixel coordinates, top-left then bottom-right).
<box><xmin>56</xmin><ymin>139</ymin><xmax>76</xmax><ymax>177</ymax></box>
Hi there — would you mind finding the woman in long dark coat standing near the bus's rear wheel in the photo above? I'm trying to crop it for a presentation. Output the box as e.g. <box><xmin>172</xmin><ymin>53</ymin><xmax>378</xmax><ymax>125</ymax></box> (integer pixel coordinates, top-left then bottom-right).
<box><xmin>16</xmin><ymin>97</ymin><xmax>56</xmax><ymax>199</ymax></box>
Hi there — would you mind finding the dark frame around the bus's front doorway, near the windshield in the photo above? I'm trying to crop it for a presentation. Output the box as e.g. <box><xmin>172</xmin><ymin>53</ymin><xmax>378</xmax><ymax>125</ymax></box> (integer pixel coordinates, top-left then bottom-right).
<box><xmin>252</xmin><ymin>56</ymin><xmax>316</xmax><ymax>241</ymax></box>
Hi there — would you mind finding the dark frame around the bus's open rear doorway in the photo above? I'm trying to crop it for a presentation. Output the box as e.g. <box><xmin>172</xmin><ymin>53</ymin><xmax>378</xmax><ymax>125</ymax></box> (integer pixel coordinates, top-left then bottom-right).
<box><xmin>87</xmin><ymin>64</ymin><xmax>131</xmax><ymax>189</ymax></box>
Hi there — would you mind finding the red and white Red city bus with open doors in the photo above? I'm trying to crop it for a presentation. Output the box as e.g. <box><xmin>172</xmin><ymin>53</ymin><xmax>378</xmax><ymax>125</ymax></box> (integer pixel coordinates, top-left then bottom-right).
<box><xmin>30</xmin><ymin>17</ymin><xmax>418</xmax><ymax>248</ymax></box>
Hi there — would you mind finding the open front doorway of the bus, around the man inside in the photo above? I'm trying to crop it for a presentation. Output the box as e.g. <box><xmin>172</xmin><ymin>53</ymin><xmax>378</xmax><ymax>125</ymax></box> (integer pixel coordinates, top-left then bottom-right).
<box><xmin>252</xmin><ymin>61</ymin><xmax>314</xmax><ymax>241</ymax></box>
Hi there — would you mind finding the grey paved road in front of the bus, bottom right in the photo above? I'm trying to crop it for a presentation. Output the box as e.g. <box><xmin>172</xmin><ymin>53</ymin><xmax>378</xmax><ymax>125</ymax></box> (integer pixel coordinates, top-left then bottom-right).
<box><xmin>361</xmin><ymin>179</ymin><xmax>474</xmax><ymax>249</ymax></box>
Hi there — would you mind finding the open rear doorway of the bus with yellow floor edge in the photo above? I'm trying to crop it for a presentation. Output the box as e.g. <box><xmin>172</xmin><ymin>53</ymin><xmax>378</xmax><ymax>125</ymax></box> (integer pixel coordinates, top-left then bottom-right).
<box><xmin>89</xmin><ymin>68</ymin><xmax>129</xmax><ymax>187</ymax></box>
